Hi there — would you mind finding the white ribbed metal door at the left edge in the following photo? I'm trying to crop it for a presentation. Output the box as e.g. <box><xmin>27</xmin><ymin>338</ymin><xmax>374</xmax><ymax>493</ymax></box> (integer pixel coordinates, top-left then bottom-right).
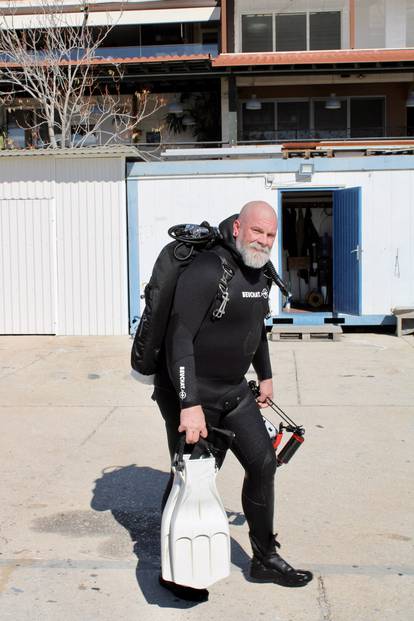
<box><xmin>0</xmin><ymin>198</ymin><xmax>56</xmax><ymax>334</ymax></box>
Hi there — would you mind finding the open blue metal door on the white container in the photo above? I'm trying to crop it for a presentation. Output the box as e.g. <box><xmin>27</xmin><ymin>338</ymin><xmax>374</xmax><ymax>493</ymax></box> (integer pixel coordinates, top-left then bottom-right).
<box><xmin>333</xmin><ymin>188</ymin><xmax>361</xmax><ymax>315</ymax></box>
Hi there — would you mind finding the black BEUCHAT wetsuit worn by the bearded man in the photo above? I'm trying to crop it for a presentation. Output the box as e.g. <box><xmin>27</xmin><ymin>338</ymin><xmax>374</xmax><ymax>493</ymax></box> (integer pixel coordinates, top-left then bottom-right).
<box><xmin>154</xmin><ymin>218</ymin><xmax>276</xmax><ymax>548</ymax></box>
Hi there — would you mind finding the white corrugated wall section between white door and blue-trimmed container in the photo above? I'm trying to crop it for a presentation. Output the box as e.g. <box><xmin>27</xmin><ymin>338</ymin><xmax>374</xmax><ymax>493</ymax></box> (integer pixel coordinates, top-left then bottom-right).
<box><xmin>55</xmin><ymin>158</ymin><xmax>128</xmax><ymax>335</ymax></box>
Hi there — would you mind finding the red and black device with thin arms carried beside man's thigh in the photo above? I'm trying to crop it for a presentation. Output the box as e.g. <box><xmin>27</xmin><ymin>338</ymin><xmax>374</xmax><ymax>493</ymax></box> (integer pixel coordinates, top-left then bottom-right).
<box><xmin>249</xmin><ymin>380</ymin><xmax>305</xmax><ymax>466</ymax></box>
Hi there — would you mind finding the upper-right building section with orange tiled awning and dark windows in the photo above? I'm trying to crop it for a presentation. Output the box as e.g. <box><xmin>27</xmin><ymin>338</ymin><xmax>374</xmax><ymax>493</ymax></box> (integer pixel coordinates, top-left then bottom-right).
<box><xmin>218</xmin><ymin>0</ymin><xmax>414</xmax><ymax>143</ymax></box>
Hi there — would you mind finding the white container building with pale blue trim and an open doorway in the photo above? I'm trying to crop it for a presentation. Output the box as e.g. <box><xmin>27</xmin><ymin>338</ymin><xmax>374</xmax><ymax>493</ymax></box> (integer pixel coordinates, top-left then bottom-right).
<box><xmin>128</xmin><ymin>155</ymin><xmax>414</xmax><ymax>325</ymax></box>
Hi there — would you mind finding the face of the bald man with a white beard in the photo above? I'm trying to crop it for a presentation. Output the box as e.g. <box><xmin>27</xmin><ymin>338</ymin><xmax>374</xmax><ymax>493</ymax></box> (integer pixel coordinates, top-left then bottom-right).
<box><xmin>234</xmin><ymin>210</ymin><xmax>277</xmax><ymax>269</ymax></box>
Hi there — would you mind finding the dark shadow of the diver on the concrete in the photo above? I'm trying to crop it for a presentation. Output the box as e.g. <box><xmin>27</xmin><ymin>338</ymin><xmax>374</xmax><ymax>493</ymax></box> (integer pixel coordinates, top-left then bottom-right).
<box><xmin>91</xmin><ymin>464</ymin><xmax>249</xmax><ymax>608</ymax></box>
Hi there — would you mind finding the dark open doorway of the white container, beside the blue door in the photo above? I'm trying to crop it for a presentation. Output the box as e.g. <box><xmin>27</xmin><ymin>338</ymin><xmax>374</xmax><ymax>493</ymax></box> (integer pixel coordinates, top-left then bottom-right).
<box><xmin>281</xmin><ymin>190</ymin><xmax>333</xmax><ymax>313</ymax></box>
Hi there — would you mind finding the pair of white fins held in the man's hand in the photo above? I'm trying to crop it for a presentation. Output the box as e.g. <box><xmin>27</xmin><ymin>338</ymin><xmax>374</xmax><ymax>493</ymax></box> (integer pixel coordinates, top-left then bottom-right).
<box><xmin>161</xmin><ymin>448</ymin><xmax>230</xmax><ymax>589</ymax></box>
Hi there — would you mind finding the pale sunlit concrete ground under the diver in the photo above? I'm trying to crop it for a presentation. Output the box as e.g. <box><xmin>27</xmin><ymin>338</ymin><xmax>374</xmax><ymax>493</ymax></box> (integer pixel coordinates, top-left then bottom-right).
<box><xmin>0</xmin><ymin>334</ymin><xmax>414</xmax><ymax>621</ymax></box>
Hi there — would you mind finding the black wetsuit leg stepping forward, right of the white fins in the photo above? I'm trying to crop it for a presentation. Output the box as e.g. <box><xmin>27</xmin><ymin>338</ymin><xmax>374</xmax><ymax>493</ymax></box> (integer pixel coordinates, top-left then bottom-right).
<box><xmin>221</xmin><ymin>390</ymin><xmax>276</xmax><ymax>549</ymax></box>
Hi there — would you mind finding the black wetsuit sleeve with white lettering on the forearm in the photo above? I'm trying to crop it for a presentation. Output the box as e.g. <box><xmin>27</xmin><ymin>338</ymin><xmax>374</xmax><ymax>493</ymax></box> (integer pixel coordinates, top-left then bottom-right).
<box><xmin>166</xmin><ymin>253</ymin><xmax>223</xmax><ymax>408</ymax></box>
